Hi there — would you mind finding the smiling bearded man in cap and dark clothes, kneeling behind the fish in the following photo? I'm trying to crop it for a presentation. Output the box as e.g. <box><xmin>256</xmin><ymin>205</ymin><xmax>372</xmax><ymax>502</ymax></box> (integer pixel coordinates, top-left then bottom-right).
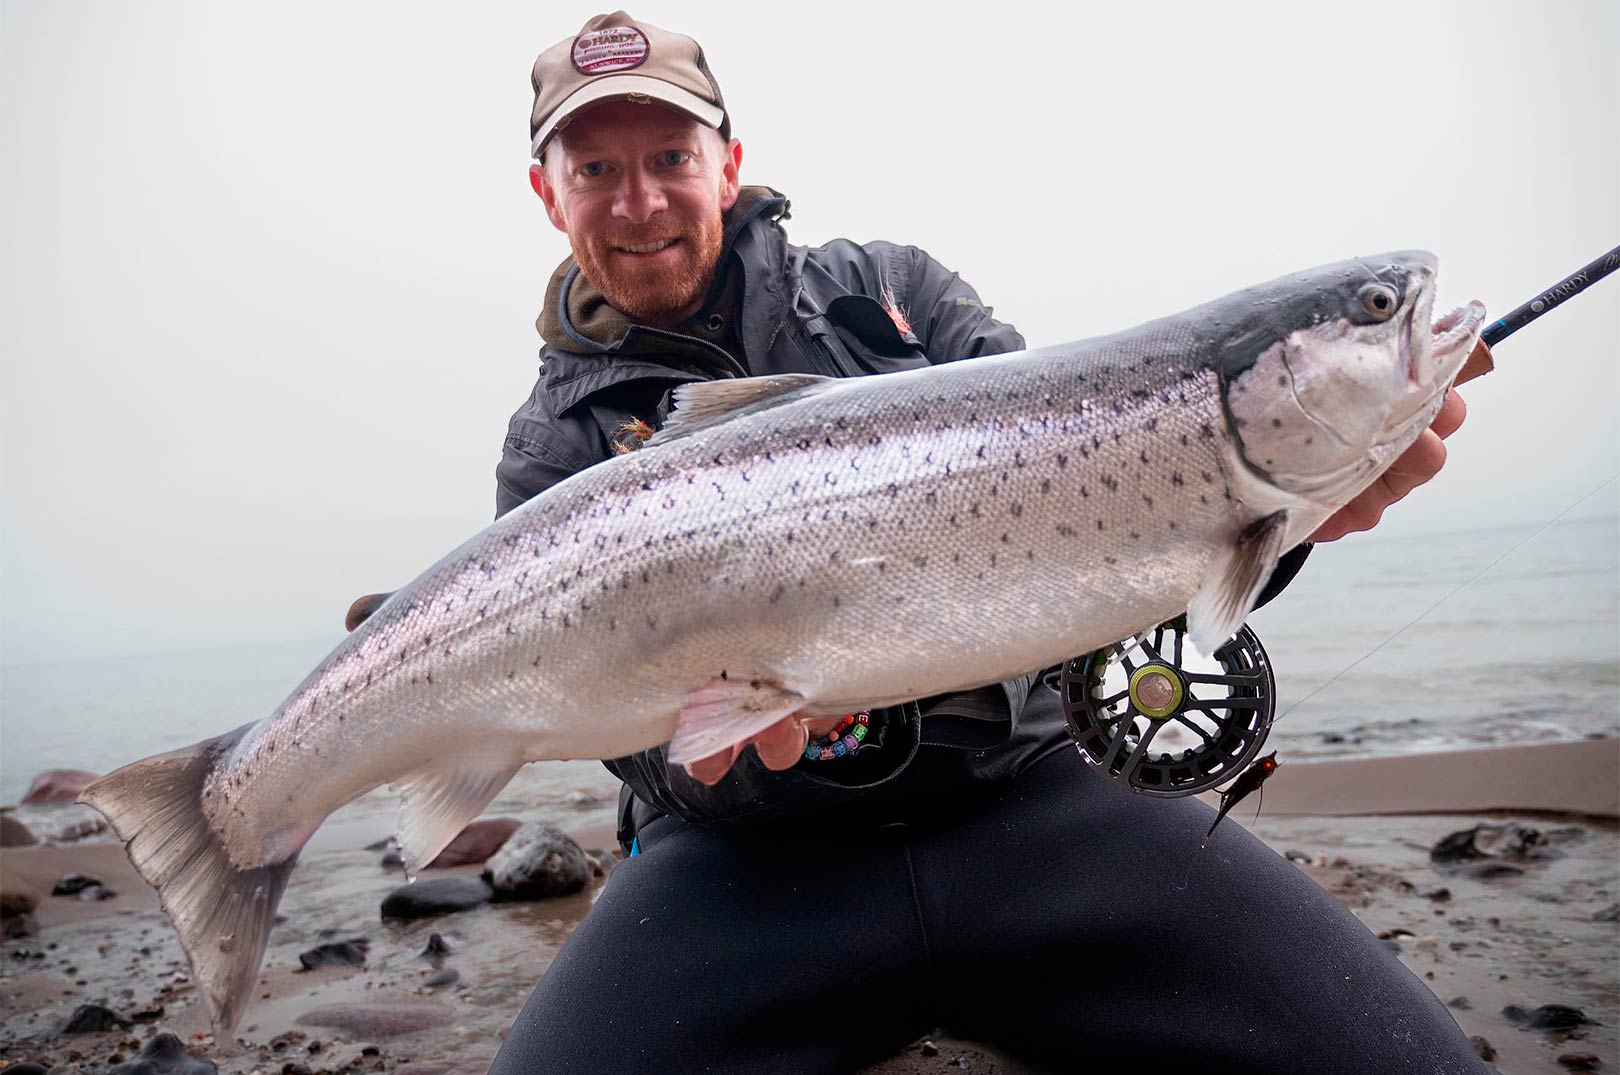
<box><xmin>492</xmin><ymin>11</ymin><xmax>1487</xmax><ymax>1075</ymax></box>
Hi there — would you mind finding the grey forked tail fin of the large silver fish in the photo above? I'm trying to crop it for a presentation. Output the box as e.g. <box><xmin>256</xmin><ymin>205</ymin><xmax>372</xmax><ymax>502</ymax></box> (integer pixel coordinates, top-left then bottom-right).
<box><xmin>79</xmin><ymin>725</ymin><xmax>301</xmax><ymax>1041</ymax></box>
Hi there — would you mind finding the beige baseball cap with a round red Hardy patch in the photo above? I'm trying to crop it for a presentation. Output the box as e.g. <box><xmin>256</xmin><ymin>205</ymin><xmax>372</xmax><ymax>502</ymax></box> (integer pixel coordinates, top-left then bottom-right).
<box><xmin>528</xmin><ymin>11</ymin><xmax>731</xmax><ymax>159</ymax></box>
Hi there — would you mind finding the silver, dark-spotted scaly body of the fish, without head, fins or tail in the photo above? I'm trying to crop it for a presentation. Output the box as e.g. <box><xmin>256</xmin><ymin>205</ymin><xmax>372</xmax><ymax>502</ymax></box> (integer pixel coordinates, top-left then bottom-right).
<box><xmin>212</xmin><ymin>332</ymin><xmax>1249</xmax><ymax>832</ymax></box>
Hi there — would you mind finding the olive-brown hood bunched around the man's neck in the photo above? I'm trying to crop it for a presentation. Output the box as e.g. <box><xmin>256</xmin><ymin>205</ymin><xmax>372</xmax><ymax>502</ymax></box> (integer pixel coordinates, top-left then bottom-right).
<box><xmin>535</xmin><ymin>186</ymin><xmax>787</xmax><ymax>351</ymax></box>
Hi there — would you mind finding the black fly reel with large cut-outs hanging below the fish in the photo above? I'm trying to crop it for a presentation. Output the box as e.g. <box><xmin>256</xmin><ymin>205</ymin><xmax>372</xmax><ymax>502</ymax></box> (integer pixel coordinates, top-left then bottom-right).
<box><xmin>1058</xmin><ymin>615</ymin><xmax>1277</xmax><ymax>798</ymax></box>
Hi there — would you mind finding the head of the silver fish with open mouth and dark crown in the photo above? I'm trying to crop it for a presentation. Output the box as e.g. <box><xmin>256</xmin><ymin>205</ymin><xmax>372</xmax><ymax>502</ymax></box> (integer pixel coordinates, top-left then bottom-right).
<box><xmin>1215</xmin><ymin>251</ymin><xmax>1486</xmax><ymax>510</ymax></box>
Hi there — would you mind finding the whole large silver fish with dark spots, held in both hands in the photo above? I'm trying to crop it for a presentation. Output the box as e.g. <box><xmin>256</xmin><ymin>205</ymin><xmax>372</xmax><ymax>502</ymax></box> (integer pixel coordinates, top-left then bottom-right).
<box><xmin>84</xmin><ymin>253</ymin><xmax>1484</xmax><ymax>1035</ymax></box>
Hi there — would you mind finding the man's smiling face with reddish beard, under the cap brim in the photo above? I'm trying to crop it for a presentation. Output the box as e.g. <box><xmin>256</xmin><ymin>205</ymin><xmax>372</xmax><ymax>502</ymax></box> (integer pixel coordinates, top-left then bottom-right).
<box><xmin>530</xmin><ymin>100</ymin><xmax>742</xmax><ymax>327</ymax></box>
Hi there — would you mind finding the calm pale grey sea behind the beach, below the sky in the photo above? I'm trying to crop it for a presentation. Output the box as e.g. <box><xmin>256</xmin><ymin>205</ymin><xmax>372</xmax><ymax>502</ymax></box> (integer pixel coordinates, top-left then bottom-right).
<box><xmin>0</xmin><ymin>518</ymin><xmax>1620</xmax><ymax>803</ymax></box>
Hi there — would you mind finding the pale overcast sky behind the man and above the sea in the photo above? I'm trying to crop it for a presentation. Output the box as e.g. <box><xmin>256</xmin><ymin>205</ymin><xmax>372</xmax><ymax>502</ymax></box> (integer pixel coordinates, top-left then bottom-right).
<box><xmin>0</xmin><ymin>0</ymin><xmax>1620</xmax><ymax>664</ymax></box>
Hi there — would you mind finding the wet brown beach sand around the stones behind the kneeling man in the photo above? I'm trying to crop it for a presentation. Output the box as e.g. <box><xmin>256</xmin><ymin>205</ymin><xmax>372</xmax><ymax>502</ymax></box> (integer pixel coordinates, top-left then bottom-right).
<box><xmin>0</xmin><ymin>740</ymin><xmax>1620</xmax><ymax>1075</ymax></box>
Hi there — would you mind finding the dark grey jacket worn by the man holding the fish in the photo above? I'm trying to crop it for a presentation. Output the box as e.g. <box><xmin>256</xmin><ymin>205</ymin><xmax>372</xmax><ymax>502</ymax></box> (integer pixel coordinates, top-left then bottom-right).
<box><xmin>496</xmin><ymin>188</ymin><xmax>1302</xmax><ymax>843</ymax></box>
